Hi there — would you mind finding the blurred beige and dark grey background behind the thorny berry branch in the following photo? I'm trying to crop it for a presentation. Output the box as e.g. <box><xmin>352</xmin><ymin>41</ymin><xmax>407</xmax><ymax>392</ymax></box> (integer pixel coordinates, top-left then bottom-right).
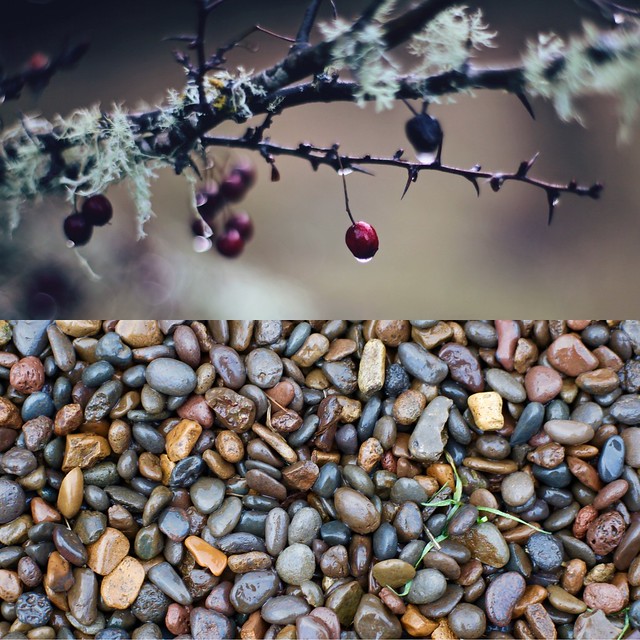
<box><xmin>0</xmin><ymin>0</ymin><xmax>640</xmax><ymax>318</ymax></box>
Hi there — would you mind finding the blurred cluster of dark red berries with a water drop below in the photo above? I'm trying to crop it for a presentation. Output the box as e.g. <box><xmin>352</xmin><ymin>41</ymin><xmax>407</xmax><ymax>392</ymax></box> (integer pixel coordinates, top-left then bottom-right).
<box><xmin>191</xmin><ymin>160</ymin><xmax>256</xmax><ymax>258</ymax></box>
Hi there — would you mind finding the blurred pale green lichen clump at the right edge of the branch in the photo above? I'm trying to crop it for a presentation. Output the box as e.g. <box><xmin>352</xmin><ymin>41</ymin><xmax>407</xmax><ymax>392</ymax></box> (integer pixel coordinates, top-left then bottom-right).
<box><xmin>523</xmin><ymin>21</ymin><xmax>640</xmax><ymax>139</ymax></box>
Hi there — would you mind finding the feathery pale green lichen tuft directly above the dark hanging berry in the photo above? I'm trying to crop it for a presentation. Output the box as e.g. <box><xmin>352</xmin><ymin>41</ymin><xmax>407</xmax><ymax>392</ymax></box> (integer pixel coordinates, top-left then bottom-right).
<box><xmin>408</xmin><ymin>6</ymin><xmax>496</xmax><ymax>74</ymax></box>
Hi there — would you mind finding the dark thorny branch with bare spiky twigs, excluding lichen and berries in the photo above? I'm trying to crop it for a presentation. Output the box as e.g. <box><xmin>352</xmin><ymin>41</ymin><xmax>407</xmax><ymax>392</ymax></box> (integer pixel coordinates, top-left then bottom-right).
<box><xmin>0</xmin><ymin>0</ymin><xmax>640</xmax><ymax>232</ymax></box>
